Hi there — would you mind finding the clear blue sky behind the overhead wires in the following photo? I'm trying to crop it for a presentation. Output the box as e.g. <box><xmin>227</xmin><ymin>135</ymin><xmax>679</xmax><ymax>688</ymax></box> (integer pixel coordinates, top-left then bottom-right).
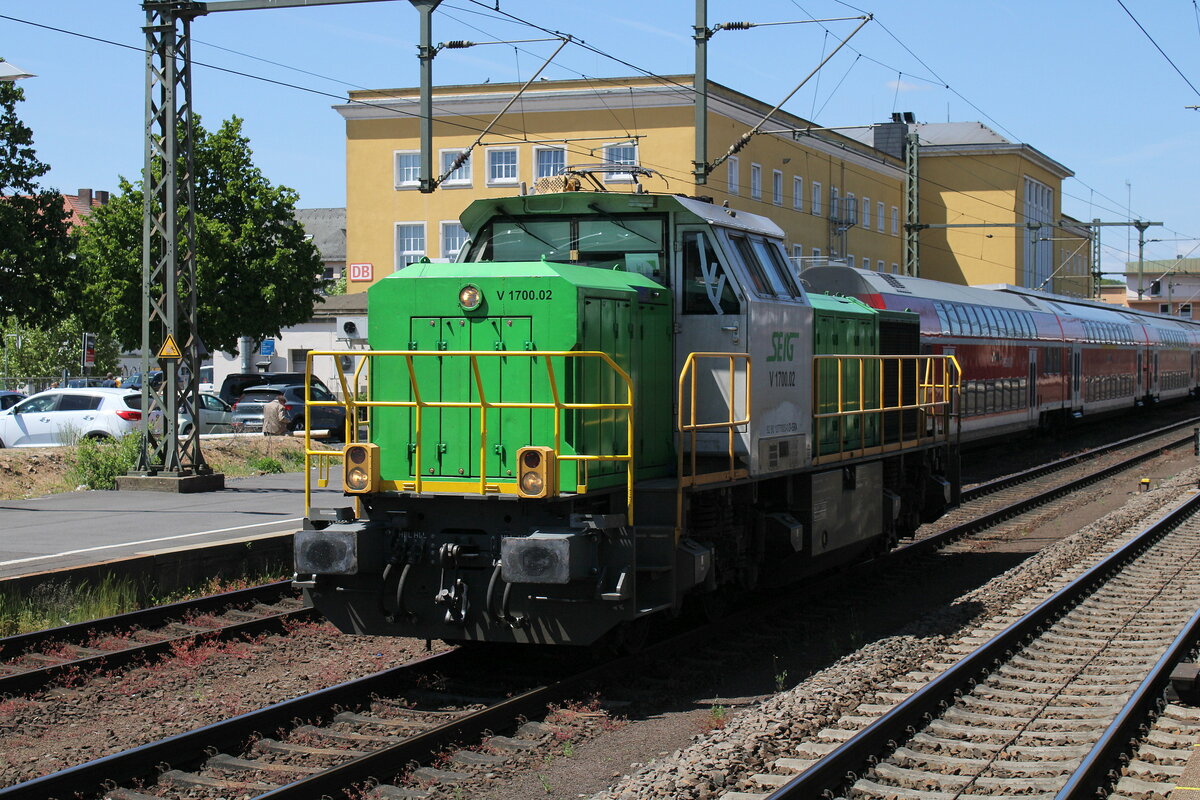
<box><xmin>0</xmin><ymin>0</ymin><xmax>1200</xmax><ymax>270</ymax></box>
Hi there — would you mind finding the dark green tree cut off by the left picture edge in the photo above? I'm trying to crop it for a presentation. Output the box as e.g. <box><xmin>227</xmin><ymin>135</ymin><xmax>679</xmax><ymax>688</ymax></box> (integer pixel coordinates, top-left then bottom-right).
<box><xmin>0</xmin><ymin>74</ymin><xmax>78</xmax><ymax>324</ymax></box>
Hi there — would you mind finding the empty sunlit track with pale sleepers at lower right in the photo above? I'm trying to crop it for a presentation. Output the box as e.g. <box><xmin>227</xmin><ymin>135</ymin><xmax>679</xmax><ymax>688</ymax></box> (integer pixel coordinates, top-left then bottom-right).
<box><xmin>724</xmin><ymin>494</ymin><xmax>1200</xmax><ymax>800</ymax></box>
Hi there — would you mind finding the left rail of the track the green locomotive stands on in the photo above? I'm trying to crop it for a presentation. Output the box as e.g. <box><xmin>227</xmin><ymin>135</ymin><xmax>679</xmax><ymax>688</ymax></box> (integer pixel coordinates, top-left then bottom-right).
<box><xmin>0</xmin><ymin>650</ymin><xmax>462</xmax><ymax>800</ymax></box>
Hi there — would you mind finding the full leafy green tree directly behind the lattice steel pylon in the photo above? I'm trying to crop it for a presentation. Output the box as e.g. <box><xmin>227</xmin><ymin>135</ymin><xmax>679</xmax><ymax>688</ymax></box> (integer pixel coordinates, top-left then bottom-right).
<box><xmin>77</xmin><ymin>116</ymin><xmax>324</xmax><ymax>351</ymax></box>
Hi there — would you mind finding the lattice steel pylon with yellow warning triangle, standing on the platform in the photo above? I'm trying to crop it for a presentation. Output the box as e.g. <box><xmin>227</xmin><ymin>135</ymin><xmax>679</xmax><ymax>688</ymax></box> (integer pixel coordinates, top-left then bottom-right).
<box><xmin>136</xmin><ymin>1</ymin><xmax>212</xmax><ymax>477</ymax></box>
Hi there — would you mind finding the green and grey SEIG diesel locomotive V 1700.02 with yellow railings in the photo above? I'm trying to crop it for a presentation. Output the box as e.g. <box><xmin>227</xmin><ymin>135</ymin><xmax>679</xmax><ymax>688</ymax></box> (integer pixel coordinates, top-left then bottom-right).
<box><xmin>295</xmin><ymin>176</ymin><xmax>959</xmax><ymax>645</ymax></box>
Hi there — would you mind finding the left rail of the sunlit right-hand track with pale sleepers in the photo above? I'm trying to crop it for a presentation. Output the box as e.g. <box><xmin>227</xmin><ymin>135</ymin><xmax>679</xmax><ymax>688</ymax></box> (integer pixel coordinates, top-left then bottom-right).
<box><xmin>767</xmin><ymin>492</ymin><xmax>1200</xmax><ymax>800</ymax></box>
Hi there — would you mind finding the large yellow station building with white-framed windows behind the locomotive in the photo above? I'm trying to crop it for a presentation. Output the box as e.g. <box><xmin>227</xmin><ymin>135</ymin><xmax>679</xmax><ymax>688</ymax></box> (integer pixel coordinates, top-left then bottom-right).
<box><xmin>336</xmin><ymin>76</ymin><xmax>1087</xmax><ymax>297</ymax></box>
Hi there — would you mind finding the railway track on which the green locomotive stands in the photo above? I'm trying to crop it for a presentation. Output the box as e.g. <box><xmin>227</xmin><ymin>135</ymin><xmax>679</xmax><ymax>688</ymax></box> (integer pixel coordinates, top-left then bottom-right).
<box><xmin>0</xmin><ymin>419</ymin><xmax>1190</xmax><ymax>800</ymax></box>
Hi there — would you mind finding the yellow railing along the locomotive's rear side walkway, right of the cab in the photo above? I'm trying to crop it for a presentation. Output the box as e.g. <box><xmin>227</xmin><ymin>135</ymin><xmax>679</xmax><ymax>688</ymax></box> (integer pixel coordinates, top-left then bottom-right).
<box><xmin>812</xmin><ymin>355</ymin><xmax>962</xmax><ymax>464</ymax></box>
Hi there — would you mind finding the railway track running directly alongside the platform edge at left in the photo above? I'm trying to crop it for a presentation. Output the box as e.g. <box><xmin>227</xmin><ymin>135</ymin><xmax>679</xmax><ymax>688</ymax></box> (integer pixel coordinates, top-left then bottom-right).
<box><xmin>0</xmin><ymin>581</ymin><xmax>316</xmax><ymax>696</ymax></box>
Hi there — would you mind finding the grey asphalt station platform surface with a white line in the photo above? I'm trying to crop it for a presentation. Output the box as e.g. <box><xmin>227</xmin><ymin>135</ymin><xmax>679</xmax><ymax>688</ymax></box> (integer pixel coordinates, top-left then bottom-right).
<box><xmin>0</xmin><ymin>473</ymin><xmax>346</xmax><ymax>581</ymax></box>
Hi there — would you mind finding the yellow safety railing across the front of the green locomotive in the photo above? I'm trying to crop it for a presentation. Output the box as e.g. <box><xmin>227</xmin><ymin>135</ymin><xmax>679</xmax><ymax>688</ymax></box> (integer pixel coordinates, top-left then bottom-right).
<box><xmin>305</xmin><ymin>350</ymin><xmax>635</xmax><ymax>523</ymax></box>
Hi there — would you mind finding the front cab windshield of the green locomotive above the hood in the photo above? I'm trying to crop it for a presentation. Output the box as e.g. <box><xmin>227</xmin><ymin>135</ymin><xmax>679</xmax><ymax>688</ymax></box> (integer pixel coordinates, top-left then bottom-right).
<box><xmin>463</xmin><ymin>212</ymin><xmax>667</xmax><ymax>284</ymax></box>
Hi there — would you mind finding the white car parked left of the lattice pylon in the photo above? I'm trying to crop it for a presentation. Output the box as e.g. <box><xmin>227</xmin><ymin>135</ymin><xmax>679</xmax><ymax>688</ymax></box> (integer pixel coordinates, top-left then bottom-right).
<box><xmin>0</xmin><ymin>387</ymin><xmax>152</xmax><ymax>447</ymax></box>
